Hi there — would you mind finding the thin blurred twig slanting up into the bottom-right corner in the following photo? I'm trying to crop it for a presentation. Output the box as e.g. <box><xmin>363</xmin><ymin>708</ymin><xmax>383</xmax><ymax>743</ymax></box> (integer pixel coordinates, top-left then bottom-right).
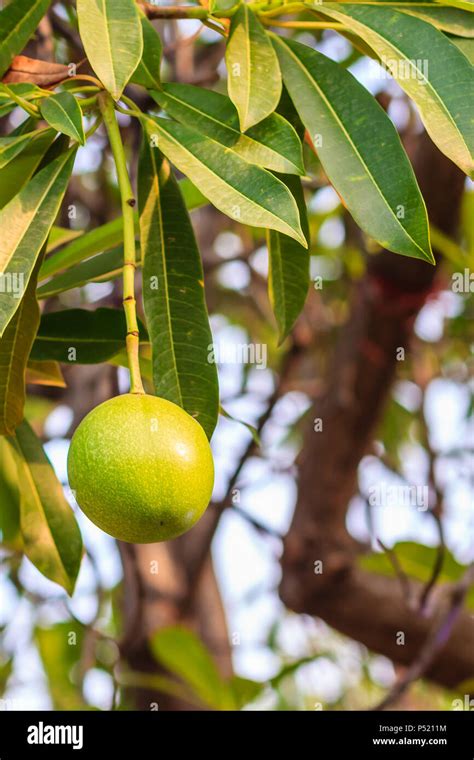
<box><xmin>372</xmin><ymin>563</ymin><xmax>474</xmax><ymax>712</ymax></box>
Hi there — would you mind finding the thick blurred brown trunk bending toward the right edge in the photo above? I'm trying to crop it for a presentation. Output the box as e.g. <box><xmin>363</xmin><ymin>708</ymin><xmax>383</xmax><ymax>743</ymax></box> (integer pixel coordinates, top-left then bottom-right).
<box><xmin>280</xmin><ymin>135</ymin><xmax>474</xmax><ymax>686</ymax></box>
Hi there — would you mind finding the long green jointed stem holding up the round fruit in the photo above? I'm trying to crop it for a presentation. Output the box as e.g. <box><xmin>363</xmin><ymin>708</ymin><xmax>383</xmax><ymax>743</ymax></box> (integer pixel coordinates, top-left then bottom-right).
<box><xmin>99</xmin><ymin>92</ymin><xmax>145</xmax><ymax>394</ymax></box>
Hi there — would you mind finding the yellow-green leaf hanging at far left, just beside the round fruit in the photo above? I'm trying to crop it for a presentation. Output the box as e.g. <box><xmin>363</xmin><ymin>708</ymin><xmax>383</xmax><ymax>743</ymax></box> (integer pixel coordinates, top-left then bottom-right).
<box><xmin>8</xmin><ymin>420</ymin><xmax>82</xmax><ymax>594</ymax></box>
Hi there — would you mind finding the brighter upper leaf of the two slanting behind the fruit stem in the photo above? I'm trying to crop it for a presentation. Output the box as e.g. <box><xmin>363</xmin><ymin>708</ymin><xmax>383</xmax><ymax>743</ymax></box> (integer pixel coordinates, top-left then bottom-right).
<box><xmin>38</xmin><ymin>175</ymin><xmax>209</xmax><ymax>280</ymax></box>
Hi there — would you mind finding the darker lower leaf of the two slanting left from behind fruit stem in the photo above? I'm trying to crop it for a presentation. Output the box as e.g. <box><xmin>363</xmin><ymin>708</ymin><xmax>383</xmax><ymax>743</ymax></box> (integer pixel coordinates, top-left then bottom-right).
<box><xmin>37</xmin><ymin>246</ymin><xmax>123</xmax><ymax>298</ymax></box>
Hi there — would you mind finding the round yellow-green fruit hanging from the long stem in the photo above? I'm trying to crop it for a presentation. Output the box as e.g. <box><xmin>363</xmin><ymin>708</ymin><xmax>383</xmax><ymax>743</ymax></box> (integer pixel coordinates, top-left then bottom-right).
<box><xmin>68</xmin><ymin>393</ymin><xmax>214</xmax><ymax>543</ymax></box>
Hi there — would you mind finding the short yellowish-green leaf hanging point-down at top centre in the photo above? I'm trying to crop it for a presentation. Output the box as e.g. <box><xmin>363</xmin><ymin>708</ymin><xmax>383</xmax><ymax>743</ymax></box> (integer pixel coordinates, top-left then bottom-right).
<box><xmin>225</xmin><ymin>3</ymin><xmax>281</xmax><ymax>132</ymax></box>
